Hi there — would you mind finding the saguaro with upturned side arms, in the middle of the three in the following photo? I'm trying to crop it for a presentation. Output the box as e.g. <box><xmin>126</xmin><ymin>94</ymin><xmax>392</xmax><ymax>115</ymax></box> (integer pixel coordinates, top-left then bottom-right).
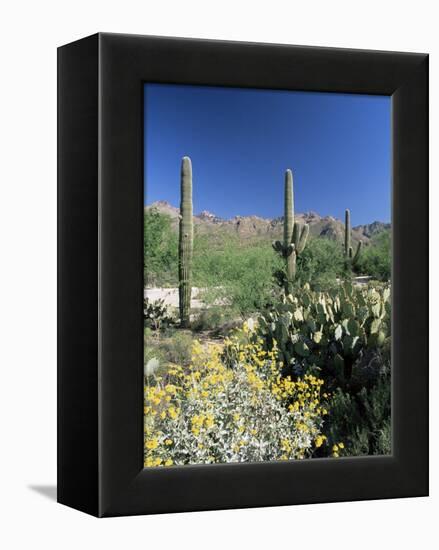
<box><xmin>273</xmin><ymin>169</ymin><xmax>309</xmax><ymax>294</ymax></box>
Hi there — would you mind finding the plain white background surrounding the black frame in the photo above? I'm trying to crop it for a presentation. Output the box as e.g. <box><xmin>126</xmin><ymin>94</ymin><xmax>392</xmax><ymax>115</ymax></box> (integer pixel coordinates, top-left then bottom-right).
<box><xmin>0</xmin><ymin>0</ymin><xmax>439</xmax><ymax>550</ymax></box>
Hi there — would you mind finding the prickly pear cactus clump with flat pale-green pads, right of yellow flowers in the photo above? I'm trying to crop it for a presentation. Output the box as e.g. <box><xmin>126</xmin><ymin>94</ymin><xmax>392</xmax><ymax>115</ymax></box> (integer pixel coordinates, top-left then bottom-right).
<box><xmin>258</xmin><ymin>282</ymin><xmax>391</xmax><ymax>385</ymax></box>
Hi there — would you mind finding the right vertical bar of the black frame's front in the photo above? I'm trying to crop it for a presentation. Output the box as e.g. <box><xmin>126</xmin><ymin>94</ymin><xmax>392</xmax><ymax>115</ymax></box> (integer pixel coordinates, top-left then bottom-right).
<box><xmin>392</xmin><ymin>55</ymin><xmax>429</xmax><ymax>496</ymax></box>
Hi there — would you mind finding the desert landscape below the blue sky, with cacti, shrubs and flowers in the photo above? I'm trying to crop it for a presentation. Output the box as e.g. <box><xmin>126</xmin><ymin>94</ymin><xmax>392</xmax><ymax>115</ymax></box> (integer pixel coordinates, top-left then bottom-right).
<box><xmin>144</xmin><ymin>157</ymin><xmax>391</xmax><ymax>466</ymax></box>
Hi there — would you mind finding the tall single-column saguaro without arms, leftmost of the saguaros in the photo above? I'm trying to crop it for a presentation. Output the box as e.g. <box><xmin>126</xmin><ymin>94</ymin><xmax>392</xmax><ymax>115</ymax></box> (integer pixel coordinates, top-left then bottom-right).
<box><xmin>178</xmin><ymin>157</ymin><xmax>194</xmax><ymax>327</ymax></box>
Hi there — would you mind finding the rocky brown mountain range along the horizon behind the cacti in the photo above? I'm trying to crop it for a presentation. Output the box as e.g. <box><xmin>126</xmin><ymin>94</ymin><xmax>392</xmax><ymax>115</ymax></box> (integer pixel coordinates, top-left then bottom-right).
<box><xmin>145</xmin><ymin>201</ymin><xmax>390</xmax><ymax>244</ymax></box>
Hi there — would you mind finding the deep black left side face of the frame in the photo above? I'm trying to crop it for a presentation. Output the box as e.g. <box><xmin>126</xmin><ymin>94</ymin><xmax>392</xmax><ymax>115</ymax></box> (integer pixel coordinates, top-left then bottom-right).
<box><xmin>57</xmin><ymin>35</ymin><xmax>99</xmax><ymax>515</ymax></box>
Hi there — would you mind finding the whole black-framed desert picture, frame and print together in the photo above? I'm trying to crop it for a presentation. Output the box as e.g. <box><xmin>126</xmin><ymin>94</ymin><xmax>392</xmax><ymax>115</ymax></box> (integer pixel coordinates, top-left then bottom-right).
<box><xmin>58</xmin><ymin>33</ymin><xmax>428</xmax><ymax>517</ymax></box>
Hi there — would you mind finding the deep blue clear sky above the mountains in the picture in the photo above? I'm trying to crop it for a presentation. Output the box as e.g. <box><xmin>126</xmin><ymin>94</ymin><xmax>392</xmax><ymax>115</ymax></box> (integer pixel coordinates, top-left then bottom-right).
<box><xmin>145</xmin><ymin>84</ymin><xmax>391</xmax><ymax>226</ymax></box>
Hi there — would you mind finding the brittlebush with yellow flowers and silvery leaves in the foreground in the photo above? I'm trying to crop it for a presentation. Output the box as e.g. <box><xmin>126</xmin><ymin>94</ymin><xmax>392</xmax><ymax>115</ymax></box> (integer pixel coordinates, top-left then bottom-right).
<box><xmin>144</xmin><ymin>325</ymin><xmax>327</xmax><ymax>467</ymax></box>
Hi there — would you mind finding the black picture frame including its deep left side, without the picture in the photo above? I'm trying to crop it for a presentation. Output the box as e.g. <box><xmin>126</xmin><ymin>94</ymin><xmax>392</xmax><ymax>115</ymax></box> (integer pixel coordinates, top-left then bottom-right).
<box><xmin>58</xmin><ymin>33</ymin><xmax>428</xmax><ymax>517</ymax></box>
